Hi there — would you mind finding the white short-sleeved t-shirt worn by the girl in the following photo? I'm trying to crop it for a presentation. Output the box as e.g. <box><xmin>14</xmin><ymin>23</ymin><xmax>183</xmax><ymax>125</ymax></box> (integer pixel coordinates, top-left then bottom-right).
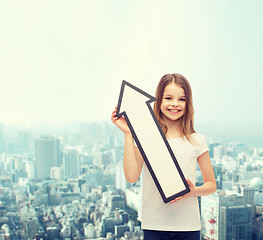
<box><xmin>141</xmin><ymin>133</ymin><xmax>208</xmax><ymax>231</ymax></box>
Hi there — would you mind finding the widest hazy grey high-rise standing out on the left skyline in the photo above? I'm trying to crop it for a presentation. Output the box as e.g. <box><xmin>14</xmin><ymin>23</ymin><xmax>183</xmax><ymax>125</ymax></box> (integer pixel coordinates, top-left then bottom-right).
<box><xmin>35</xmin><ymin>136</ymin><xmax>61</xmax><ymax>179</ymax></box>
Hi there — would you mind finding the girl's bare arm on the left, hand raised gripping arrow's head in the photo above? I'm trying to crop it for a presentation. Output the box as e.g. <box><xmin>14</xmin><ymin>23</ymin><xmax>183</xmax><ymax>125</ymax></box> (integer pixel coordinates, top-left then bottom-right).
<box><xmin>111</xmin><ymin>107</ymin><xmax>143</xmax><ymax>183</ymax></box>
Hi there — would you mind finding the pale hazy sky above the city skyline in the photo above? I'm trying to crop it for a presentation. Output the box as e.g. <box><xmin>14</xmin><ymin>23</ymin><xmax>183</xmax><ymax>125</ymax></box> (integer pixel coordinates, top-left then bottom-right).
<box><xmin>0</xmin><ymin>0</ymin><xmax>263</xmax><ymax>143</ymax></box>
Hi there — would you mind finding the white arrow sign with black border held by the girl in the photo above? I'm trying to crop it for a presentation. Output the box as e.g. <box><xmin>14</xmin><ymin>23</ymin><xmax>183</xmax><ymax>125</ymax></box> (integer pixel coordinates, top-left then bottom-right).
<box><xmin>116</xmin><ymin>80</ymin><xmax>190</xmax><ymax>203</ymax></box>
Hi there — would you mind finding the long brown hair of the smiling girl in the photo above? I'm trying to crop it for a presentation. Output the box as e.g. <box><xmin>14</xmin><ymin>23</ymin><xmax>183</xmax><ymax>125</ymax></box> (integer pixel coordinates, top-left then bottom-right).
<box><xmin>153</xmin><ymin>73</ymin><xmax>195</xmax><ymax>143</ymax></box>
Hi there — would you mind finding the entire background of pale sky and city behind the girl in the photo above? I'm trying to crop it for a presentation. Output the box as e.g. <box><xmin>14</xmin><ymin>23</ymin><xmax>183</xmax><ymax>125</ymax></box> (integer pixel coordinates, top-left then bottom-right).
<box><xmin>0</xmin><ymin>0</ymin><xmax>263</xmax><ymax>240</ymax></box>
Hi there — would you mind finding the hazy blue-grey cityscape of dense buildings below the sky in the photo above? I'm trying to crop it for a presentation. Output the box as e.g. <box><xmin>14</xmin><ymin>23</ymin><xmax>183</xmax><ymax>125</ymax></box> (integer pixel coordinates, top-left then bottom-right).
<box><xmin>0</xmin><ymin>122</ymin><xmax>263</xmax><ymax>240</ymax></box>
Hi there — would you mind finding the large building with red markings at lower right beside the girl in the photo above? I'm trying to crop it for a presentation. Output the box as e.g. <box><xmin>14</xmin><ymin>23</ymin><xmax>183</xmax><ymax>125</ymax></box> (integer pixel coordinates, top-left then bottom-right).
<box><xmin>201</xmin><ymin>190</ymin><xmax>253</xmax><ymax>240</ymax></box>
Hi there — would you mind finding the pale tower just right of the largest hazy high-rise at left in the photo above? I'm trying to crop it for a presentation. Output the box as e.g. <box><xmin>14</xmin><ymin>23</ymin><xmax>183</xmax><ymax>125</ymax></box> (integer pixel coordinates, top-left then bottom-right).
<box><xmin>63</xmin><ymin>149</ymin><xmax>80</xmax><ymax>178</ymax></box>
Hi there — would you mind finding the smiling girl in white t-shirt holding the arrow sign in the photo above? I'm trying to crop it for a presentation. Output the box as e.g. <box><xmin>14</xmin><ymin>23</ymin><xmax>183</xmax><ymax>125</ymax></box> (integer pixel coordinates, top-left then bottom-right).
<box><xmin>111</xmin><ymin>74</ymin><xmax>216</xmax><ymax>240</ymax></box>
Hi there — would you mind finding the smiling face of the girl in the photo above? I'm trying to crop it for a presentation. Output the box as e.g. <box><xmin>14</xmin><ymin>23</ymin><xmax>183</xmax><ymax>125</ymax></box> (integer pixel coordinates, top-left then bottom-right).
<box><xmin>161</xmin><ymin>83</ymin><xmax>186</xmax><ymax>122</ymax></box>
